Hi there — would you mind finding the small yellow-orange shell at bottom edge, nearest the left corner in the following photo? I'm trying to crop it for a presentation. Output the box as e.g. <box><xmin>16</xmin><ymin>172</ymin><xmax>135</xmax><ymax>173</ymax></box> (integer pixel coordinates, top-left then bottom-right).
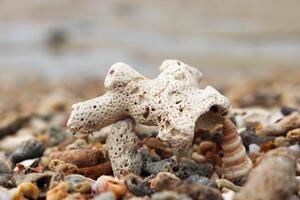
<box><xmin>10</xmin><ymin>183</ymin><xmax>40</xmax><ymax>200</ymax></box>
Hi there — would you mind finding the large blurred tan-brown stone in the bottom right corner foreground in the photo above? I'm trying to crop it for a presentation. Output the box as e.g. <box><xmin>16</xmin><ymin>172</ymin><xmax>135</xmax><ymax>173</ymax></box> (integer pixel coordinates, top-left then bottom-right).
<box><xmin>234</xmin><ymin>147</ymin><xmax>297</xmax><ymax>200</ymax></box>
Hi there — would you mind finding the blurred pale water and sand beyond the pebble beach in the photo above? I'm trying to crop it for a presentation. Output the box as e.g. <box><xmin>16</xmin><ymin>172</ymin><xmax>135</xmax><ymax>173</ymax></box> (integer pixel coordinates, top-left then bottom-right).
<box><xmin>0</xmin><ymin>0</ymin><xmax>300</xmax><ymax>82</ymax></box>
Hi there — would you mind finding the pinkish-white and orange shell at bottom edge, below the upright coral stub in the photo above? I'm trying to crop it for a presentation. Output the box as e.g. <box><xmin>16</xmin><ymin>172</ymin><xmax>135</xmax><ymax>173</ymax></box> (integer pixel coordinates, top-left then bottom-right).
<box><xmin>93</xmin><ymin>176</ymin><xmax>127</xmax><ymax>199</ymax></box>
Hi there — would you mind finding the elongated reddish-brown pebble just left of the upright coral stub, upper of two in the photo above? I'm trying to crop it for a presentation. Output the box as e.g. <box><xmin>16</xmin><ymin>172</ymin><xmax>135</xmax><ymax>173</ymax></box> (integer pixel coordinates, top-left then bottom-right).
<box><xmin>50</xmin><ymin>149</ymin><xmax>105</xmax><ymax>168</ymax></box>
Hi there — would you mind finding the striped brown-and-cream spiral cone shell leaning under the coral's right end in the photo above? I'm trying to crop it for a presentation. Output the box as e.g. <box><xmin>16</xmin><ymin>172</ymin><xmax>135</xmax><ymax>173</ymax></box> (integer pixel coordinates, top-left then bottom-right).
<box><xmin>218</xmin><ymin>118</ymin><xmax>252</xmax><ymax>180</ymax></box>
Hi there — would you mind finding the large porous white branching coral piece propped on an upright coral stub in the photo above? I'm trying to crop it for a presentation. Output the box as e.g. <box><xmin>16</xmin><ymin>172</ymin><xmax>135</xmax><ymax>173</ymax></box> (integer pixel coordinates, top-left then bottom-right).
<box><xmin>68</xmin><ymin>60</ymin><xmax>229</xmax><ymax>158</ymax></box>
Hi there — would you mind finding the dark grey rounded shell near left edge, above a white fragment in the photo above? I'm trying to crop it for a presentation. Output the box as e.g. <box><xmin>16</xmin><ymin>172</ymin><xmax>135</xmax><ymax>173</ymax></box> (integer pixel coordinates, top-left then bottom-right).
<box><xmin>10</xmin><ymin>140</ymin><xmax>44</xmax><ymax>164</ymax></box>
